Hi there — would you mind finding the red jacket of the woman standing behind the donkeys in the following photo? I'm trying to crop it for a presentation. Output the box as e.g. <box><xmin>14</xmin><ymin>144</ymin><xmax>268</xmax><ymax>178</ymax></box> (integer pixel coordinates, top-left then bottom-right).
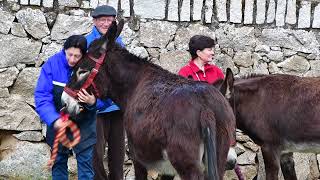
<box><xmin>178</xmin><ymin>60</ymin><xmax>224</xmax><ymax>84</ymax></box>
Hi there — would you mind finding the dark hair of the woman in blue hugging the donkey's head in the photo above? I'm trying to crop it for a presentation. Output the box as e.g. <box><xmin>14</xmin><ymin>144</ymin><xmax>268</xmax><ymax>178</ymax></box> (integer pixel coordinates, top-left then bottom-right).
<box><xmin>63</xmin><ymin>35</ymin><xmax>87</xmax><ymax>54</ymax></box>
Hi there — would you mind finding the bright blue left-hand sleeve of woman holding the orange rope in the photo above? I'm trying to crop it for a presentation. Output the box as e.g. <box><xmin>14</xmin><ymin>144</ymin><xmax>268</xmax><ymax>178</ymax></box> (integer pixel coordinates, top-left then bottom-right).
<box><xmin>34</xmin><ymin>63</ymin><xmax>60</xmax><ymax>126</ymax></box>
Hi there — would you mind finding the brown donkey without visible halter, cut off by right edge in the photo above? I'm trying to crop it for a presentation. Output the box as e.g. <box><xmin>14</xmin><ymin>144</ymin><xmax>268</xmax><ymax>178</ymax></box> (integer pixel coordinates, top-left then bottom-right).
<box><xmin>226</xmin><ymin>69</ymin><xmax>320</xmax><ymax>180</ymax></box>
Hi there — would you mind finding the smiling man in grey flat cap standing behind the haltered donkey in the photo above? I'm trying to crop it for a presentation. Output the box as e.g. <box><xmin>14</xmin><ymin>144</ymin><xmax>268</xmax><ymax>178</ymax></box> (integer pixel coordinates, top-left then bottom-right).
<box><xmin>86</xmin><ymin>5</ymin><xmax>124</xmax><ymax>180</ymax></box>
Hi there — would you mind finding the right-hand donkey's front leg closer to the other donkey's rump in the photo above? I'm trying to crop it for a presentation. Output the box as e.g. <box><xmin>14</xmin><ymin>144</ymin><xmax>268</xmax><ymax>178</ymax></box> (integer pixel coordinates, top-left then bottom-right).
<box><xmin>261</xmin><ymin>144</ymin><xmax>280</xmax><ymax>180</ymax></box>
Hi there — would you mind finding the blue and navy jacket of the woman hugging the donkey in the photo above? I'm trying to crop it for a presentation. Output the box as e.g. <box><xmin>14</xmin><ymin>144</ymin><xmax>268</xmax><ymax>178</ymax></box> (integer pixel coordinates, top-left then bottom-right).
<box><xmin>34</xmin><ymin>50</ymin><xmax>96</xmax><ymax>153</ymax></box>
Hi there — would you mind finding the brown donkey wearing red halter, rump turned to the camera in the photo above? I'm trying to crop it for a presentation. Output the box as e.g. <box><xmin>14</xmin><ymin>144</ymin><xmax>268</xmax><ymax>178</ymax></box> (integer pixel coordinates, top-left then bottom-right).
<box><xmin>62</xmin><ymin>20</ymin><xmax>235</xmax><ymax>180</ymax></box>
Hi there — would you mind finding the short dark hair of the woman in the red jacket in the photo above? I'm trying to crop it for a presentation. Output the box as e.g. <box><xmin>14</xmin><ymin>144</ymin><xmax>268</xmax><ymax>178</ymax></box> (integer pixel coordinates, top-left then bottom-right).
<box><xmin>189</xmin><ymin>35</ymin><xmax>215</xmax><ymax>59</ymax></box>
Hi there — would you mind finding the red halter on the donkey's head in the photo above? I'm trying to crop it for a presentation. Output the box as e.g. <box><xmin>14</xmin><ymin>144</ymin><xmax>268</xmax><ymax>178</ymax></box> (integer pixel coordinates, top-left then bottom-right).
<box><xmin>64</xmin><ymin>53</ymin><xmax>106</xmax><ymax>99</ymax></box>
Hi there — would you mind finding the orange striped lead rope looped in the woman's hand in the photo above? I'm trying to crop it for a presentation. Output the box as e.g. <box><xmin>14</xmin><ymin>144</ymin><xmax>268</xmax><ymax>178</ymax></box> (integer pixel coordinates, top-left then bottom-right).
<box><xmin>48</xmin><ymin>113</ymin><xmax>81</xmax><ymax>169</ymax></box>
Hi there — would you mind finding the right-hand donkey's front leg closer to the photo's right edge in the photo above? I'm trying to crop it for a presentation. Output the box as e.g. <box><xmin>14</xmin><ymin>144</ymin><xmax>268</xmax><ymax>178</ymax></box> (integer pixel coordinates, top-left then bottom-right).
<box><xmin>280</xmin><ymin>152</ymin><xmax>297</xmax><ymax>180</ymax></box>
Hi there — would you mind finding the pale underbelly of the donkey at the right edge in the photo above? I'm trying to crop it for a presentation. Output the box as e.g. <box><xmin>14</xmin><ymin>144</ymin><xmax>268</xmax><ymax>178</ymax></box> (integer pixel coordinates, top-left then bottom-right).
<box><xmin>282</xmin><ymin>142</ymin><xmax>320</xmax><ymax>153</ymax></box>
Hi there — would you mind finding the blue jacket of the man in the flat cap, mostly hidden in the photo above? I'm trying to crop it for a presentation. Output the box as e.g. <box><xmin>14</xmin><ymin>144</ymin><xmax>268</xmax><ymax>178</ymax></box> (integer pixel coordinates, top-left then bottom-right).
<box><xmin>86</xmin><ymin>26</ymin><xmax>125</xmax><ymax>113</ymax></box>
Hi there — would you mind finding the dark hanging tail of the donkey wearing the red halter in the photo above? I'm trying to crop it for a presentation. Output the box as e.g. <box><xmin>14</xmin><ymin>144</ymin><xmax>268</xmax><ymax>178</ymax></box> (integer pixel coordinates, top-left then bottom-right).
<box><xmin>203</xmin><ymin>127</ymin><xmax>219</xmax><ymax>180</ymax></box>
